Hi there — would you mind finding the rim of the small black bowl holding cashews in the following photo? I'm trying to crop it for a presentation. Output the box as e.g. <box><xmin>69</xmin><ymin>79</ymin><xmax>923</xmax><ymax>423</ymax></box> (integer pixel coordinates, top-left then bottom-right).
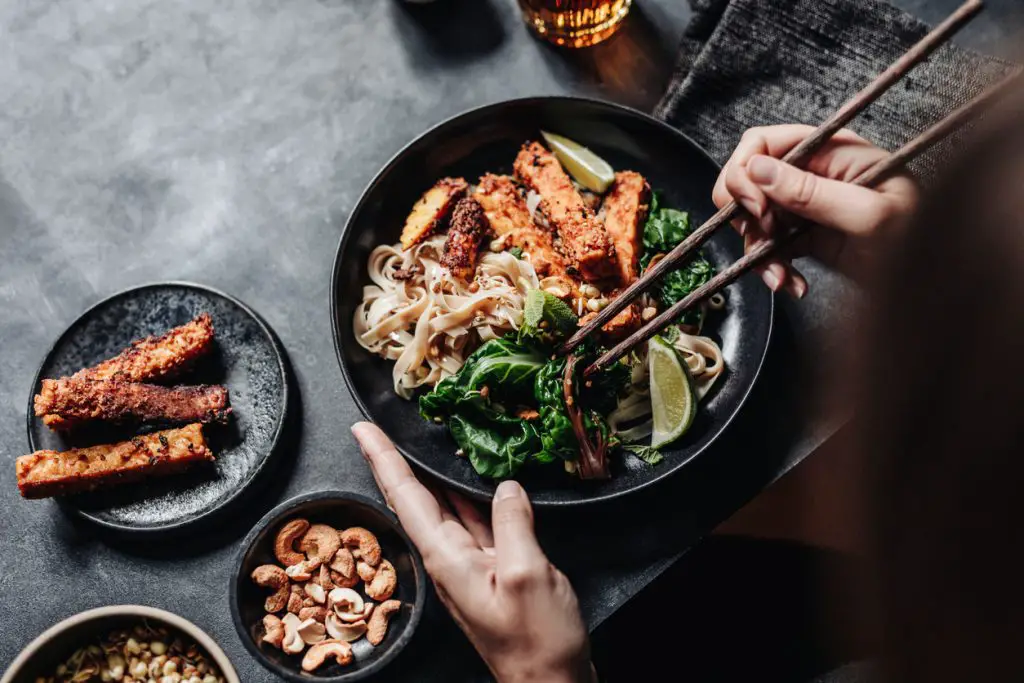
<box><xmin>230</xmin><ymin>488</ymin><xmax>427</xmax><ymax>683</ymax></box>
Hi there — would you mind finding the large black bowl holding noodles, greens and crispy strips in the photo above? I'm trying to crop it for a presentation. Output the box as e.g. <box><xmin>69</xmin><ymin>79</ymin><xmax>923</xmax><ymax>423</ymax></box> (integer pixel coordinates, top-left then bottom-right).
<box><xmin>331</xmin><ymin>97</ymin><xmax>773</xmax><ymax>505</ymax></box>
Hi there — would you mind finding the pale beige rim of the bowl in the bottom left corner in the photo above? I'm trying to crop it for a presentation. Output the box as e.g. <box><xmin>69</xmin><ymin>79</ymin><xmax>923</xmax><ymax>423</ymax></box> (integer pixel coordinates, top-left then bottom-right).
<box><xmin>0</xmin><ymin>604</ymin><xmax>242</xmax><ymax>683</ymax></box>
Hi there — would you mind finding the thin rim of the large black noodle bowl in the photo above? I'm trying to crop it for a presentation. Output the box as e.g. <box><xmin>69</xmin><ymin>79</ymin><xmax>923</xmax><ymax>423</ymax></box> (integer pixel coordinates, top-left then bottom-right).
<box><xmin>329</xmin><ymin>95</ymin><xmax>775</xmax><ymax>509</ymax></box>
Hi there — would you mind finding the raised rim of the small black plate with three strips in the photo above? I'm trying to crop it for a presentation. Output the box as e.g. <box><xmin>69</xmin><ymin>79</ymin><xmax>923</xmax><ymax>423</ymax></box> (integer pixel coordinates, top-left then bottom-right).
<box><xmin>25</xmin><ymin>280</ymin><xmax>293</xmax><ymax>537</ymax></box>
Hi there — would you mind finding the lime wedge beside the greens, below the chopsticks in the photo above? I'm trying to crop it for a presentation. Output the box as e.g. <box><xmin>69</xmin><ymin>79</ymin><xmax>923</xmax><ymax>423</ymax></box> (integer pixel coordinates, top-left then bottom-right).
<box><xmin>647</xmin><ymin>337</ymin><xmax>697</xmax><ymax>449</ymax></box>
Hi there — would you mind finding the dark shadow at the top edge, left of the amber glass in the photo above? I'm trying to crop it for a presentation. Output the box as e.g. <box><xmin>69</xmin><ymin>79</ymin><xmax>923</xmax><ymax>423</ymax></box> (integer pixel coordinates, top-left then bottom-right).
<box><xmin>391</xmin><ymin>0</ymin><xmax>506</xmax><ymax>71</ymax></box>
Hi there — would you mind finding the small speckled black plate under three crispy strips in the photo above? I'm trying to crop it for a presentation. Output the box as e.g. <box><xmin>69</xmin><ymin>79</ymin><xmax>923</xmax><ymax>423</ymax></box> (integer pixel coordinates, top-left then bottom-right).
<box><xmin>28</xmin><ymin>283</ymin><xmax>289</xmax><ymax>531</ymax></box>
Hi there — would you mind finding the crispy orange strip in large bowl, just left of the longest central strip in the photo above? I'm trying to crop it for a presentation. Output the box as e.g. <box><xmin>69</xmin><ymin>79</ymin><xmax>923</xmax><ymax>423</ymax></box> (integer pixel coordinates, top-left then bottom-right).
<box><xmin>473</xmin><ymin>173</ymin><xmax>565</xmax><ymax>278</ymax></box>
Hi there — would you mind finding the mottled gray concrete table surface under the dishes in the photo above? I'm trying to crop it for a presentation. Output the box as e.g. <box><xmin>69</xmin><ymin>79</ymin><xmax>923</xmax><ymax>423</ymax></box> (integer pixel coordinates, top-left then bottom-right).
<box><xmin>0</xmin><ymin>0</ymin><xmax>1013</xmax><ymax>681</ymax></box>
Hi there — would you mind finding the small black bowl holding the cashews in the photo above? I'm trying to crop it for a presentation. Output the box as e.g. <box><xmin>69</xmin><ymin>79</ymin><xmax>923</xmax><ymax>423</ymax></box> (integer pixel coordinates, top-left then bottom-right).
<box><xmin>230</xmin><ymin>490</ymin><xmax>427</xmax><ymax>683</ymax></box>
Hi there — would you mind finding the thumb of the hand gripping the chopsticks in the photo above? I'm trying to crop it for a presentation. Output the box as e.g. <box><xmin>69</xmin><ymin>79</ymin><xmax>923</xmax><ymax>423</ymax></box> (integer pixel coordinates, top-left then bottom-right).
<box><xmin>746</xmin><ymin>155</ymin><xmax>890</xmax><ymax>234</ymax></box>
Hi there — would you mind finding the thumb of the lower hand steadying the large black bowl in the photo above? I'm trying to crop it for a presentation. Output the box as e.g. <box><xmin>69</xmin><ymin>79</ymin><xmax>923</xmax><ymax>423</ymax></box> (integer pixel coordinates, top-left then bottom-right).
<box><xmin>490</xmin><ymin>479</ymin><xmax>548</xmax><ymax>588</ymax></box>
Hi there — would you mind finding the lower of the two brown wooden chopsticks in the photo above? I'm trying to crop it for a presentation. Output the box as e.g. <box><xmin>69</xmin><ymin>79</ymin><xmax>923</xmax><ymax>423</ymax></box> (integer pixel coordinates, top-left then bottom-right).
<box><xmin>584</xmin><ymin>70</ymin><xmax>1022</xmax><ymax>376</ymax></box>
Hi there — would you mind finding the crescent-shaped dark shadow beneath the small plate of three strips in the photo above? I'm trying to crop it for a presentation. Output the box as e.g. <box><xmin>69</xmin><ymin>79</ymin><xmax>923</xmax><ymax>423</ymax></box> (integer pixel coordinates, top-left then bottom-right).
<box><xmin>60</xmin><ymin>360</ymin><xmax>302</xmax><ymax>559</ymax></box>
